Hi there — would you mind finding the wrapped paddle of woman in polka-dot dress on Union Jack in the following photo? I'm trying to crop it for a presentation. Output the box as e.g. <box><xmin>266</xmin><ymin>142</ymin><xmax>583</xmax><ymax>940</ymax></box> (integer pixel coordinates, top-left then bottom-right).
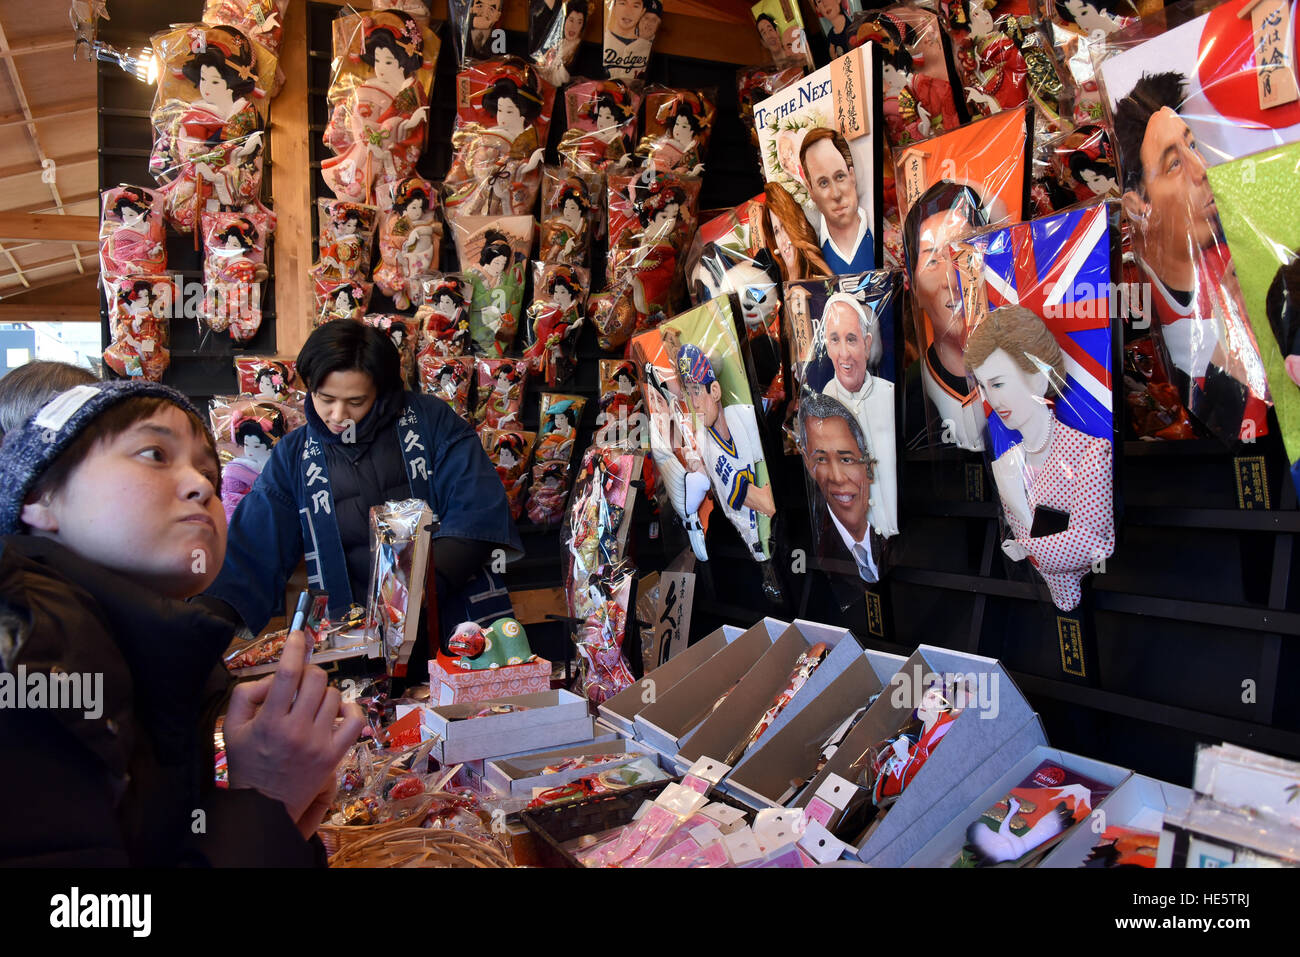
<box><xmin>957</xmin><ymin>203</ymin><xmax>1119</xmax><ymax>611</ymax></box>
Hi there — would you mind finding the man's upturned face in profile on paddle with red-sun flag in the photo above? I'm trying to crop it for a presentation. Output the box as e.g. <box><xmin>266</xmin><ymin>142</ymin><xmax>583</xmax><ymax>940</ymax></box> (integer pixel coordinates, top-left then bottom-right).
<box><xmin>1140</xmin><ymin>107</ymin><xmax>1218</xmax><ymax>255</ymax></box>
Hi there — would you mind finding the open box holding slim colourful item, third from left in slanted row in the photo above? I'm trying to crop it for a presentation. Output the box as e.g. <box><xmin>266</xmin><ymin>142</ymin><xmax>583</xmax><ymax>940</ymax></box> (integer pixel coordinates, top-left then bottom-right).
<box><xmin>677</xmin><ymin>620</ymin><xmax>862</xmax><ymax>772</ymax></box>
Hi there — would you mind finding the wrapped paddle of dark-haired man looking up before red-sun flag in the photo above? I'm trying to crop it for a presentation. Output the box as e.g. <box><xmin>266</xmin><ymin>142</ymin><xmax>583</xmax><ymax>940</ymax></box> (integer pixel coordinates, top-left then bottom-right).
<box><xmin>1095</xmin><ymin>3</ymin><xmax>1284</xmax><ymax>443</ymax></box>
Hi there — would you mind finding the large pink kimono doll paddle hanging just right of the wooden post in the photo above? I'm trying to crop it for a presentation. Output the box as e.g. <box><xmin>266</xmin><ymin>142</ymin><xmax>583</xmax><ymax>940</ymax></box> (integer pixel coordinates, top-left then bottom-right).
<box><xmin>321</xmin><ymin>10</ymin><xmax>439</xmax><ymax>203</ymax></box>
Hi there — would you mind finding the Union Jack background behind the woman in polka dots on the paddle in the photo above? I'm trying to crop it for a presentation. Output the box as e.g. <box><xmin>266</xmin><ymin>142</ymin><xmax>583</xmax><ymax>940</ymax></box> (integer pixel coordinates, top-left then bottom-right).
<box><xmin>967</xmin><ymin>203</ymin><xmax>1119</xmax><ymax>459</ymax></box>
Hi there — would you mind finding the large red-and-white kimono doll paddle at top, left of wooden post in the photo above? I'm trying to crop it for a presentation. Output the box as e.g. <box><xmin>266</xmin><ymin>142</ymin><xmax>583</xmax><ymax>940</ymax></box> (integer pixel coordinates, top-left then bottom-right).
<box><xmin>150</xmin><ymin>25</ymin><xmax>276</xmax><ymax>233</ymax></box>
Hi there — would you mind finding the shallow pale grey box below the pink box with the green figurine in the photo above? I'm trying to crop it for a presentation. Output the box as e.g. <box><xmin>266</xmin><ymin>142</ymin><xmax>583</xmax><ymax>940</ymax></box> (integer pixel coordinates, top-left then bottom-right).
<box><xmin>424</xmin><ymin>690</ymin><xmax>594</xmax><ymax>765</ymax></box>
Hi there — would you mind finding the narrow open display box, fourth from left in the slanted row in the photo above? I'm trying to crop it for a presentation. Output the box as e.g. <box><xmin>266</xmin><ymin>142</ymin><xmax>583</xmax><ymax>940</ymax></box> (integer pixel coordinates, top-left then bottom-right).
<box><xmin>723</xmin><ymin>634</ymin><xmax>904</xmax><ymax>807</ymax></box>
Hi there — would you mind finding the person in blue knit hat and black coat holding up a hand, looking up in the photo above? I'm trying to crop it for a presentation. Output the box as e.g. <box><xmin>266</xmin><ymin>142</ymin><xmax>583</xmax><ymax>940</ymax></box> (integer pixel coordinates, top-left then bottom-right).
<box><xmin>0</xmin><ymin>382</ymin><xmax>363</xmax><ymax>866</ymax></box>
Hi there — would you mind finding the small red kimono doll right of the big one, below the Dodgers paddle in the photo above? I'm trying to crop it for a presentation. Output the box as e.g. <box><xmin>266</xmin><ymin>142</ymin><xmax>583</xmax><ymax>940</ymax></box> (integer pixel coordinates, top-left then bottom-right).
<box><xmin>559</xmin><ymin>79</ymin><xmax>641</xmax><ymax>173</ymax></box>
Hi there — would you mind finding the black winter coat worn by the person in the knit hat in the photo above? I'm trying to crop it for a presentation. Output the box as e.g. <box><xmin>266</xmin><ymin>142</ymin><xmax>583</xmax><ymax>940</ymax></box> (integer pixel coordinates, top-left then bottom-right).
<box><xmin>0</xmin><ymin>536</ymin><xmax>322</xmax><ymax>867</ymax></box>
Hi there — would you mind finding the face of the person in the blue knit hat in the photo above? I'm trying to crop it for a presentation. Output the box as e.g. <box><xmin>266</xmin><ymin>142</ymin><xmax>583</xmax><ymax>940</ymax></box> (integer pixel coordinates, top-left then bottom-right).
<box><xmin>22</xmin><ymin>404</ymin><xmax>226</xmax><ymax>598</ymax></box>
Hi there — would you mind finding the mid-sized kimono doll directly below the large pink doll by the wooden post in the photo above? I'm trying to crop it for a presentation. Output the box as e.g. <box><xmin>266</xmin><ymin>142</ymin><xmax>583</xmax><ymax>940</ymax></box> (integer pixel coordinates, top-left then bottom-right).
<box><xmin>374</xmin><ymin>176</ymin><xmax>442</xmax><ymax>309</ymax></box>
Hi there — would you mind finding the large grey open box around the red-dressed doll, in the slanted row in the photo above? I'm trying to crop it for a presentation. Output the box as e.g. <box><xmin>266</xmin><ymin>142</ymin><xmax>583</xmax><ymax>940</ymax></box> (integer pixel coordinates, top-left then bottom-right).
<box><xmin>780</xmin><ymin>645</ymin><xmax>1047</xmax><ymax>867</ymax></box>
